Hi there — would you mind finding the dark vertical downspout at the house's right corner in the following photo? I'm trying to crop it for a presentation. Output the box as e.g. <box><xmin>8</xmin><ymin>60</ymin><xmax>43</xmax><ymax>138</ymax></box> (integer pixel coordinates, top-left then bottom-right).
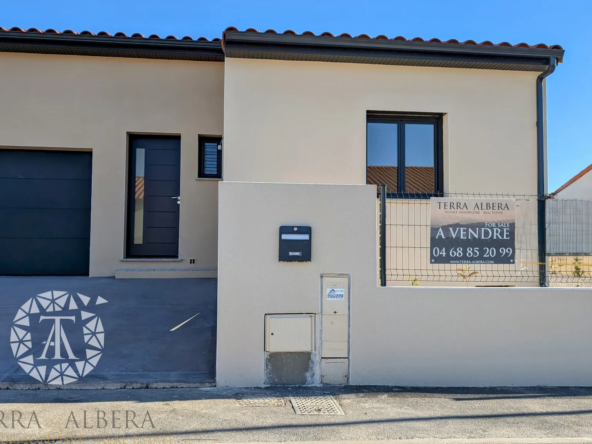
<box><xmin>537</xmin><ymin>57</ymin><xmax>557</xmax><ymax>287</ymax></box>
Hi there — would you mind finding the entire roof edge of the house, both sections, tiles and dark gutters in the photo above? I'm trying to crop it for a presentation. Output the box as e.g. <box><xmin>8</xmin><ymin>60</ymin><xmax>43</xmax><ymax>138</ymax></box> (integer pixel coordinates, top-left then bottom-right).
<box><xmin>0</xmin><ymin>27</ymin><xmax>564</xmax><ymax>72</ymax></box>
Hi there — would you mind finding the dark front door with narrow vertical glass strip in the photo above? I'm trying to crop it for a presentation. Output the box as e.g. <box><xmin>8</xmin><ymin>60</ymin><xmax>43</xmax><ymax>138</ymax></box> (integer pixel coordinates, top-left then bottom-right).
<box><xmin>127</xmin><ymin>136</ymin><xmax>181</xmax><ymax>258</ymax></box>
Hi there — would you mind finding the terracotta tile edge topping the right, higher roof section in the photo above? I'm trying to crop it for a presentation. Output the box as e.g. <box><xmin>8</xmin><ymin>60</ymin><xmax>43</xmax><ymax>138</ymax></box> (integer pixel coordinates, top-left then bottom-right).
<box><xmin>222</xmin><ymin>26</ymin><xmax>563</xmax><ymax>63</ymax></box>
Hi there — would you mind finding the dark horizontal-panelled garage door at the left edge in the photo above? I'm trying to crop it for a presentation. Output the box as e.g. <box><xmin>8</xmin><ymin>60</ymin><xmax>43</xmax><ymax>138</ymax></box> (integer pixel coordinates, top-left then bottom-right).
<box><xmin>0</xmin><ymin>150</ymin><xmax>92</xmax><ymax>275</ymax></box>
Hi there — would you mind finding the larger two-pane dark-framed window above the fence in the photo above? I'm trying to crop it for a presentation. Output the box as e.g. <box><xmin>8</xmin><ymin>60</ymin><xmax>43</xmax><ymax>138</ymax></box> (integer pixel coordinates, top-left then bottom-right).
<box><xmin>366</xmin><ymin>112</ymin><xmax>443</xmax><ymax>198</ymax></box>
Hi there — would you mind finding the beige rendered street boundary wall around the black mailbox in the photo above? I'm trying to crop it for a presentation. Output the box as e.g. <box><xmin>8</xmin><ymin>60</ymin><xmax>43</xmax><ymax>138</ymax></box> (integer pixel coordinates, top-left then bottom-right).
<box><xmin>217</xmin><ymin>182</ymin><xmax>592</xmax><ymax>386</ymax></box>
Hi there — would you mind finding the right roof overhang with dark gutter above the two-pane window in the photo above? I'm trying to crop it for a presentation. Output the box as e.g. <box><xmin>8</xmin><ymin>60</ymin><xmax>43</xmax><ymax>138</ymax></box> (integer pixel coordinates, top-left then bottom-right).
<box><xmin>223</xmin><ymin>30</ymin><xmax>564</xmax><ymax>72</ymax></box>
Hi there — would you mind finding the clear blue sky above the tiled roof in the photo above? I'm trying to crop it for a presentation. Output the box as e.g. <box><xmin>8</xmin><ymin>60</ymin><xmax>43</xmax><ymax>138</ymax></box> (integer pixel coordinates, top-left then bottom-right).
<box><xmin>0</xmin><ymin>0</ymin><xmax>592</xmax><ymax>191</ymax></box>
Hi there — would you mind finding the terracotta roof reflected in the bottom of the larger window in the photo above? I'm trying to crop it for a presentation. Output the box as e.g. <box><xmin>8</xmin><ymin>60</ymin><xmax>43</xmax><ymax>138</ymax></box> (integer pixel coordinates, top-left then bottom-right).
<box><xmin>366</xmin><ymin>166</ymin><xmax>436</xmax><ymax>193</ymax></box>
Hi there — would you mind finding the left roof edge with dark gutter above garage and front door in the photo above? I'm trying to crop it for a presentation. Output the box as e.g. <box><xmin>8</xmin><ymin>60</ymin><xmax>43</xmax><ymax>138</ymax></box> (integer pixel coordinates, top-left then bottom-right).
<box><xmin>0</xmin><ymin>31</ymin><xmax>224</xmax><ymax>62</ymax></box>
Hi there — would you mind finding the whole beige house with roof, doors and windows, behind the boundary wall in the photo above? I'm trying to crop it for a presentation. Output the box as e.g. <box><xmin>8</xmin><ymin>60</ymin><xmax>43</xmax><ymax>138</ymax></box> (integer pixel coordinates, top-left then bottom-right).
<box><xmin>0</xmin><ymin>28</ymin><xmax>563</xmax><ymax>277</ymax></box>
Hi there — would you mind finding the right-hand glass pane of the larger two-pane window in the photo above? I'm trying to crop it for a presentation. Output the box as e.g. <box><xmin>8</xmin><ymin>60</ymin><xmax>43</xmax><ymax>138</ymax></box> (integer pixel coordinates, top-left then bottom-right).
<box><xmin>405</xmin><ymin>123</ymin><xmax>436</xmax><ymax>193</ymax></box>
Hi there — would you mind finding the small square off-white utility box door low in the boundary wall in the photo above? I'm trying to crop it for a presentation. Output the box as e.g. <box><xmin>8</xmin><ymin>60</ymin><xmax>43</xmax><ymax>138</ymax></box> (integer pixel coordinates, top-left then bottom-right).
<box><xmin>265</xmin><ymin>314</ymin><xmax>315</xmax><ymax>353</ymax></box>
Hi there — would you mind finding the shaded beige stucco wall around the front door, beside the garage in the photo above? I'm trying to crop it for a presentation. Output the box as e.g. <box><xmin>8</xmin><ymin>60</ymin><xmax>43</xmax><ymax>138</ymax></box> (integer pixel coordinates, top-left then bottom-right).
<box><xmin>0</xmin><ymin>53</ymin><xmax>224</xmax><ymax>276</ymax></box>
